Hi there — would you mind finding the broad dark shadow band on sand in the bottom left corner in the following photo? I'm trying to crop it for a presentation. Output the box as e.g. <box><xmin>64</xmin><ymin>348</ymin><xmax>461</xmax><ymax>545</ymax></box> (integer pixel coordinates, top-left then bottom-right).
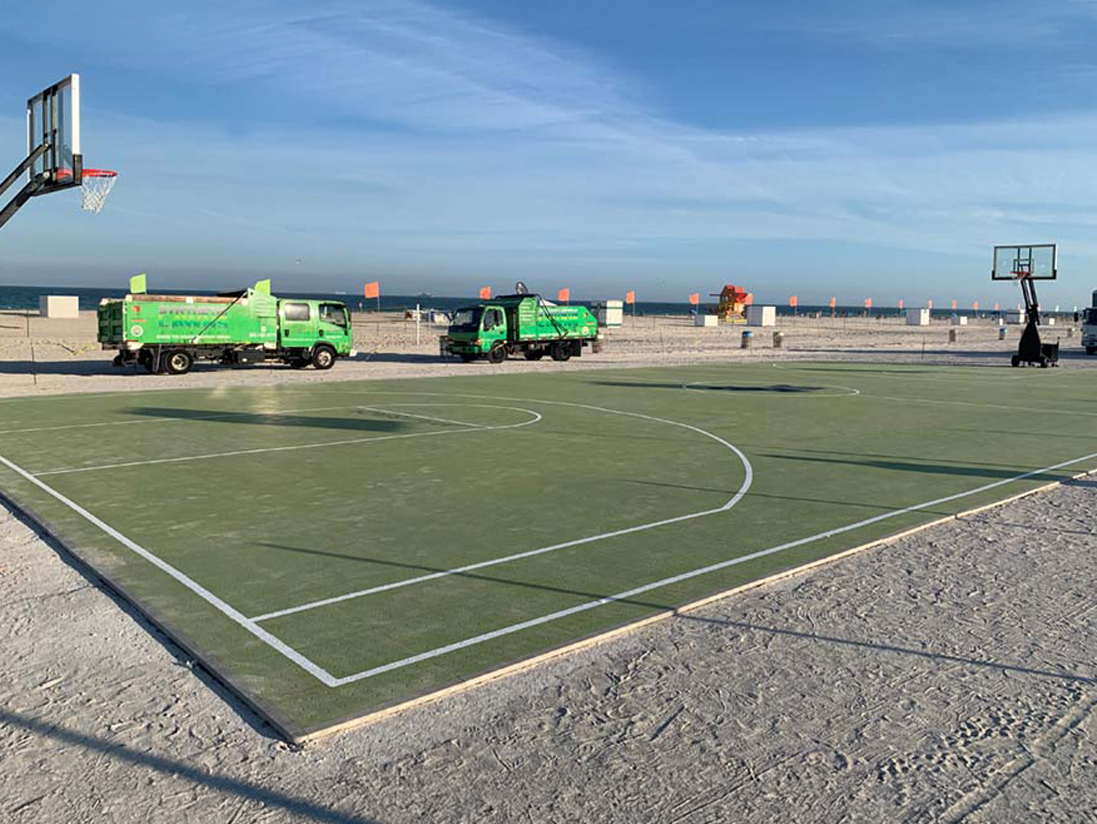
<box><xmin>0</xmin><ymin>708</ymin><xmax>375</xmax><ymax>824</ymax></box>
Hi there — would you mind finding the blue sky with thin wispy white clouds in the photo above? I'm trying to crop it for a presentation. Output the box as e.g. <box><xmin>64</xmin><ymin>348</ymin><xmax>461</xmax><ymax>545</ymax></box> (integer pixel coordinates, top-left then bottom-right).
<box><xmin>0</xmin><ymin>0</ymin><xmax>1097</xmax><ymax>307</ymax></box>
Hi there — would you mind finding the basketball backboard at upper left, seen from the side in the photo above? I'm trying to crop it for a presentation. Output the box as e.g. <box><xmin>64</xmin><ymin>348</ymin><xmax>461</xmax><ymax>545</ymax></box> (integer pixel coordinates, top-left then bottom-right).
<box><xmin>26</xmin><ymin>74</ymin><xmax>83</xmax><ymax>194</ymax></box>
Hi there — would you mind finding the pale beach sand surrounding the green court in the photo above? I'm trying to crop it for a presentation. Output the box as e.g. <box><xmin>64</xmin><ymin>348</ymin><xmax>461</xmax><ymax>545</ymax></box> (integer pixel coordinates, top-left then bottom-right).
<box><xmin>0</xmin><ymin>314</ymin><xmax>1097</xmax><ymax>823</ymax></box>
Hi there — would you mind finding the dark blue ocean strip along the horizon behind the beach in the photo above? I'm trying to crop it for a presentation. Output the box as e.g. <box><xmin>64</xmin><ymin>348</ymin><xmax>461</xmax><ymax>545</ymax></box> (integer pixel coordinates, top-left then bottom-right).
<box><xmin>0</xmin><ymin>285</ymin><xmax>1013</xmax><ymax>318</ymax></box>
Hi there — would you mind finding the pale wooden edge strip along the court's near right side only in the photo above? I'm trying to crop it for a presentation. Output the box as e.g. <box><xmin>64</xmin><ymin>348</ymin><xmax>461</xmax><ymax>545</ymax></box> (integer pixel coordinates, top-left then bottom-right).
<box><xmin>292</xmin><ymin>466</ymin><xmax>1097</xmax><ymax>745</ymax></box>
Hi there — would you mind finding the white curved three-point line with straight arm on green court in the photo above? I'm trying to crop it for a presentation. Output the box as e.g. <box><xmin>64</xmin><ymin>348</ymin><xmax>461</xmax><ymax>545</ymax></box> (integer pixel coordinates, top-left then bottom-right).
<box><xmin>251</xmin><ymin>393</ymin><xmax>754</xmax><ymax>621</ymax></box>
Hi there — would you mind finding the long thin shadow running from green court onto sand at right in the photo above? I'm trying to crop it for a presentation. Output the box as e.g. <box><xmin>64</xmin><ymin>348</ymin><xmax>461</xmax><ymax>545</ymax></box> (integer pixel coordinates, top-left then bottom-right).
<box><xmin>260</xmin><ymin>543</ymin><xmax>1097</xmax><ymax>684</ymax></box>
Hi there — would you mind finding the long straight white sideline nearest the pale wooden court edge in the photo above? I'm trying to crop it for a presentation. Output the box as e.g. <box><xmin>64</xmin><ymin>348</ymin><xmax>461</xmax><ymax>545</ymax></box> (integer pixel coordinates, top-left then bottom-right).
<box><xmin>320</xmin><ymin>452</ymin><xmax>1097</xmax><ymax>687</ymax></box>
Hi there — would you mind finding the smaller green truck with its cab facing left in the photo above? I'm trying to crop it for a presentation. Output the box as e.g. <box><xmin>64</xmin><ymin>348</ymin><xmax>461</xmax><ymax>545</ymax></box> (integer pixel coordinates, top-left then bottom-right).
<box><xmin>441</xmin><ymin>294</ymin><xmax>603</xmax><ymax>363</ymax></box>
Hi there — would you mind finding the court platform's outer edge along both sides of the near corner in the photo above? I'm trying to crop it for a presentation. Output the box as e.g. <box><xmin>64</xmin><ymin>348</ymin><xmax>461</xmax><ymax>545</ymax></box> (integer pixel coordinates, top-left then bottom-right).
<box><xmin>0</xmin><ymin>466</ymin><xmax>1097</xmax><ymax>745</ymax></box>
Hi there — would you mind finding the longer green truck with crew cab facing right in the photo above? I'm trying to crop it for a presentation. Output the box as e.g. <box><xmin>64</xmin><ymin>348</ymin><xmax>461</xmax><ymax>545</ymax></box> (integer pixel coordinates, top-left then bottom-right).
<box><xmin>98</xmin><ymin>279</ymin><xmax>355</xmax><ymax>375</ymax></box>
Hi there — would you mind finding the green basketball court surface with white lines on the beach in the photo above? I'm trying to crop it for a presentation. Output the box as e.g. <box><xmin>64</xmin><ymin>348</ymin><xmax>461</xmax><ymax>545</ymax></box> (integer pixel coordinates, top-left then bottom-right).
<box><xmin>0</xmin><ymin>363</ymin><xmax>1097</xmax><ymax>740</ymax></box>
